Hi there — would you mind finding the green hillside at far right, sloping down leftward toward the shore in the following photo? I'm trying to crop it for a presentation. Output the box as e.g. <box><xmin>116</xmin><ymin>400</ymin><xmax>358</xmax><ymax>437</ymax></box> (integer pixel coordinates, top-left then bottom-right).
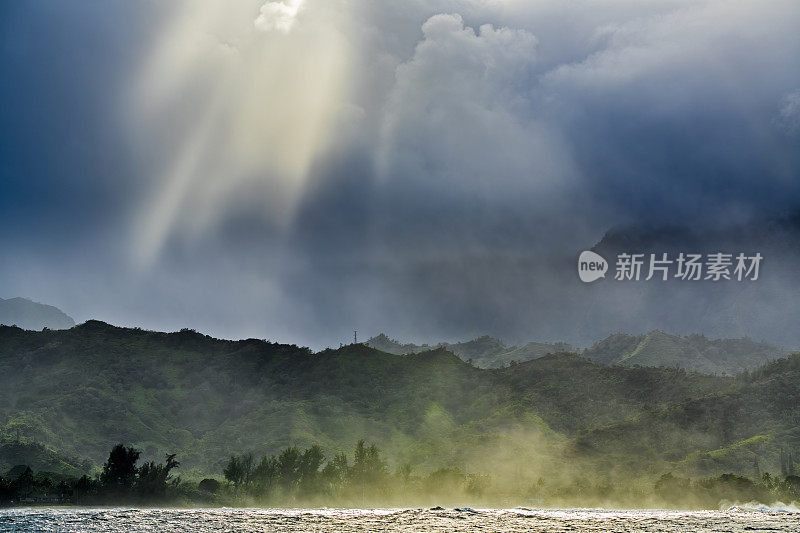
<box><xmin>574</xmin><ymin>354</ymin><xmax>800</xmax><ymax>475</ymax></box>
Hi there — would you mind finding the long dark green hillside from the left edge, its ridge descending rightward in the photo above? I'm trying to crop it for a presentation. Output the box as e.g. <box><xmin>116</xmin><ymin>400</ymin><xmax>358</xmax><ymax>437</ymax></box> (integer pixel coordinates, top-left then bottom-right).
<box><xmin>0</xmin><ymin>321</ymin><xmax>560</xmax><ymax>471</ymax></box>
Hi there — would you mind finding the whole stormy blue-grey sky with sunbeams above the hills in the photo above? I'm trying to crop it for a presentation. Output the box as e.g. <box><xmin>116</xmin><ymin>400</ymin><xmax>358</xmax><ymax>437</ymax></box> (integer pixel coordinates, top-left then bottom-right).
<box><xmin>0</xmin><ymin>0</ymin><xmax>800</xmax><ymax>348</ymax></box>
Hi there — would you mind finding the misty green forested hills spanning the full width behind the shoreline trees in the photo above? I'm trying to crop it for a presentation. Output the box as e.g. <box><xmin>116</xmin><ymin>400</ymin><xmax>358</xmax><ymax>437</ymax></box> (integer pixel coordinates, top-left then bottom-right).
<box><xmin>0</xmin><ymin>321</ymin><xmax>800</xmax><ymax>486</ymax></box>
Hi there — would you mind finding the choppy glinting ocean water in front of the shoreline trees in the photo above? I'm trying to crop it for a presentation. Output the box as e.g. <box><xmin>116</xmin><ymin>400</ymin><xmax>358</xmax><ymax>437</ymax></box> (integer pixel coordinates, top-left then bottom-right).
<box><xmin>0</xmin><ymin>506</ymin><xmax>800</xmax><ymax>532</ymax></box>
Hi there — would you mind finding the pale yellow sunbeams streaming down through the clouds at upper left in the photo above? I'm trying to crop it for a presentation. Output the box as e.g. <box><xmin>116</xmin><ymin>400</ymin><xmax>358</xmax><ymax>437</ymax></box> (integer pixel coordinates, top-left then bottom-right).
<box><xmin>130</xmin><ymin>0</ymin><xmax>348</xmax><ymax>264</ymax></box>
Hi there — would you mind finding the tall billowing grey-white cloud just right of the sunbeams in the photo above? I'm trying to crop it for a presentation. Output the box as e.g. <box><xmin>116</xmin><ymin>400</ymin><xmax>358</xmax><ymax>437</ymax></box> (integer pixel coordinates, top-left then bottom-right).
<box><xmin>381</xmin><ymin>14</ymin><xmax>574</xmax><ymax>206</ymax></box>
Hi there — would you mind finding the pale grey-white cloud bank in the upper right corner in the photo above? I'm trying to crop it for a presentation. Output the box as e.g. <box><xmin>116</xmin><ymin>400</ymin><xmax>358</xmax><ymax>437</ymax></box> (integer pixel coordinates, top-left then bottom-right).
<box><xmin>545</xmin><ymin>0</ymin><xmax>800</xmax><ymax>110</ymax></box>
